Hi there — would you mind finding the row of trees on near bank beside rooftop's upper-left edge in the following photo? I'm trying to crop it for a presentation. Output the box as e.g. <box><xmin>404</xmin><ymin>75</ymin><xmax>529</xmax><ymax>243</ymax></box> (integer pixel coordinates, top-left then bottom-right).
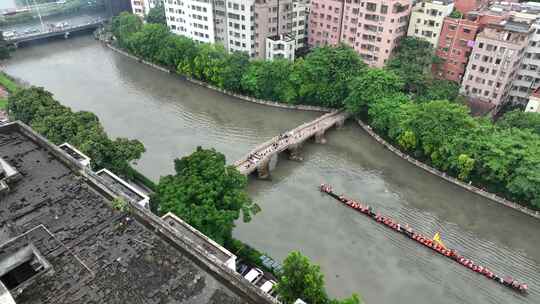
<box><xmin>8</xmin><ymin>87</ymin><xmax>145</xmax><ymax>176</ymax></box>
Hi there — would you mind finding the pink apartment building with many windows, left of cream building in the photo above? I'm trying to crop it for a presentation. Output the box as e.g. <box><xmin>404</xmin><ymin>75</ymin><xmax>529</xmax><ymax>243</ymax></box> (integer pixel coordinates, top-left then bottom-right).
<box><xmin>308</xmin><ymin>0</ymin><xmax>412</xmax><ymax>67</ymax></box>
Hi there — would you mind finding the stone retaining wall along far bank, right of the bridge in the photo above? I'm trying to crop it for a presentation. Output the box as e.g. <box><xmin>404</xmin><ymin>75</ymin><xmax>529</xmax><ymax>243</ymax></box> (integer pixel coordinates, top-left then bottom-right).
<box><xmin>357</xmin><ymin>119</ymin><xmax>540</xmax><ymax>219</ymax></box>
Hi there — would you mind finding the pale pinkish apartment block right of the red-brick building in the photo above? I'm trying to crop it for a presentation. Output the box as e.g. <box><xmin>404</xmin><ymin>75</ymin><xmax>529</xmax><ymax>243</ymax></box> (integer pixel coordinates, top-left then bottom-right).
<box><xmin>460</xmin><ymin>20</ymin><xmax>530</xmax><ymax>109</ymax></box>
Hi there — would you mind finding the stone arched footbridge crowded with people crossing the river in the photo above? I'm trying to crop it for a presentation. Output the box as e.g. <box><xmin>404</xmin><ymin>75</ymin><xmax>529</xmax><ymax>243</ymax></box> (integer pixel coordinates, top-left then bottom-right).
<box><xmin>234</xmin><ymin>111</ymin><xmax>349</xmax><ymax>178</ymax></box>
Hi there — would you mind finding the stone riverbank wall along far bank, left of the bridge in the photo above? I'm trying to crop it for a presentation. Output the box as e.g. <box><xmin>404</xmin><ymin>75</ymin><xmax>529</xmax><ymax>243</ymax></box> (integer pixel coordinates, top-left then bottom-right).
<box><xmin>105</xmin><ymin>43</ymin><xmax>336</xmax><ymax>113</ymax></box>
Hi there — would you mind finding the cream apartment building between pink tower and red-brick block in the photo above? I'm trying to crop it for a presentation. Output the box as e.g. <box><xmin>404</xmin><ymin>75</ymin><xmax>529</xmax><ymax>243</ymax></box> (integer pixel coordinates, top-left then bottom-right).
<box><xmin>407</xmin><ymin>0</ymin><xmax>454</xmax><ymax>47</ymax></box>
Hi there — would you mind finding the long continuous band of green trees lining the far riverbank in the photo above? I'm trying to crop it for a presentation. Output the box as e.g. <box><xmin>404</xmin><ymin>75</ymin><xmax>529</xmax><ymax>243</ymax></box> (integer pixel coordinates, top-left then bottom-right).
<box><xmin>109</xmin><ymin>14</ymin><xmax>540</xmax><ymax>208</ymax></box>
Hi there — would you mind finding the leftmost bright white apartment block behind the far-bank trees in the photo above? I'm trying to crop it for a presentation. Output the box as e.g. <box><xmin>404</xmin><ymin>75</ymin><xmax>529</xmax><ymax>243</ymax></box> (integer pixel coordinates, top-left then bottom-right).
<box><xmin>165</xmin><ymin>0</ymin><xmax>216</xmax><ymax>43</ymax></box>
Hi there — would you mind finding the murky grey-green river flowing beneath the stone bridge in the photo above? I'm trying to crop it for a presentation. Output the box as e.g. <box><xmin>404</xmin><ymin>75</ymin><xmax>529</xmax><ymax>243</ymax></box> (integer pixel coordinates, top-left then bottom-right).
<box><xmin>5</xmin><ymin>37</ymin><xmax>540</xmax><ymax>304</ymax></box>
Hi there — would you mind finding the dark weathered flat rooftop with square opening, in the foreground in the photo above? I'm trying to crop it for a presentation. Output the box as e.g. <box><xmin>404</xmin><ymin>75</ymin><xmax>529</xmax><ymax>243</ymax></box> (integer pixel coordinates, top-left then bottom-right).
<box><xmin>0</xmin><ymin>123</ymin><xmax>275</xmax><ymax>304</ymax></box>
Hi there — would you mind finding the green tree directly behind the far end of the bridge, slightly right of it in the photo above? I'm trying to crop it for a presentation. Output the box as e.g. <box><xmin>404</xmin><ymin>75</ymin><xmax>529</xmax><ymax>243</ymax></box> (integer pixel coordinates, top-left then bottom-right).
<box><xmin>344</xmin><ymin>69</ymin><xmax>403</xmax><ymax>114</ymax></box>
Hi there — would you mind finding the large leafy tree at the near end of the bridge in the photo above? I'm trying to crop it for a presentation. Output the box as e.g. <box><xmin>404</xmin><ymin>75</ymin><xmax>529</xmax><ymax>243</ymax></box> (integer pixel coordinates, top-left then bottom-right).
<box><xmin>152</xmin><ymin>147</ymin><xmax>258</xmax><ymax>244</ymax></box>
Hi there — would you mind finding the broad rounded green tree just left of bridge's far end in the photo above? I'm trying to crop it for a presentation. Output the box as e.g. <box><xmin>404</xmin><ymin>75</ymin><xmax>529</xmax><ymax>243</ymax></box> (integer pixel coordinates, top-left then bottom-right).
<box><xmin>291</xmin><ymin>45</ymin><xmax>366</xmax><ymax>108</ymax></box>
